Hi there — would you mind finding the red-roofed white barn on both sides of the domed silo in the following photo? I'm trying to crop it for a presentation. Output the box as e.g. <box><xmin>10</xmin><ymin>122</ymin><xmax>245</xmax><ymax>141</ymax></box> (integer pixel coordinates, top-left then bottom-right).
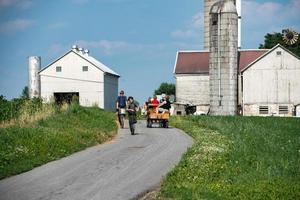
<box><xmin>174</xmin><ymin>44</ymin><xmax>300</xmax><ymax>116</ymax></box>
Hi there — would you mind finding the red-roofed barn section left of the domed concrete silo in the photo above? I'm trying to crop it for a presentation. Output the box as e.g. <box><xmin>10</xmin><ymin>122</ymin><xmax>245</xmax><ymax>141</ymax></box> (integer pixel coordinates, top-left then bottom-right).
<box><xmin>173</xmin><ymin>50</ymin><xmax>210</xmax><ymax>115</ymax></box>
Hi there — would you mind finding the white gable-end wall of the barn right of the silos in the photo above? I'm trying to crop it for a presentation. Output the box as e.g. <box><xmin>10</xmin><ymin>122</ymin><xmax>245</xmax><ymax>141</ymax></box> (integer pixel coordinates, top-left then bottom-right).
<box><xmin>243</xmin><ymin>47</ymin><xmax>300</xmax><ymax>115</ymax></box>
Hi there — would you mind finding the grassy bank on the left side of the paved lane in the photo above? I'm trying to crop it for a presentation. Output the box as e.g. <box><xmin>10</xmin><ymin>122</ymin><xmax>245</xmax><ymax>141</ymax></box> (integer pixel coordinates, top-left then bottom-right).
<box><xmin>0</xmin><ymin>104</ymin><xmax>117</xmax><ymax>179</ymax></box>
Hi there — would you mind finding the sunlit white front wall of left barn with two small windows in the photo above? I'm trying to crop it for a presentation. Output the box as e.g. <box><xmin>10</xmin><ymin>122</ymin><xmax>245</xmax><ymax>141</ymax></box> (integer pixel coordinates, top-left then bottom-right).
<box><xmin>40</xmin><ymin>52</ymin><xmax>104</xmax><ymax>108</ymax></box>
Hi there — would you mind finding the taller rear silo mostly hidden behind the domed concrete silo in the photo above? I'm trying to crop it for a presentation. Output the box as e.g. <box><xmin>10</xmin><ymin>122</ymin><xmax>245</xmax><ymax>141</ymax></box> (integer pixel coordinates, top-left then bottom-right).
<box><xmin>204</xmin><ymin>0</ymin><xmax>242</xmax><ymax>50</ymax></box>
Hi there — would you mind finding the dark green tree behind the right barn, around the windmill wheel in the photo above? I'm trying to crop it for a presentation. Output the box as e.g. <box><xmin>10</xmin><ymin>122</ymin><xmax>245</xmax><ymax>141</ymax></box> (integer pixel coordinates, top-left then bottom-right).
<box><xmin>259</xmin><ymin>32</ymin><xmax>300</xmax><ymax>57</ymax></box>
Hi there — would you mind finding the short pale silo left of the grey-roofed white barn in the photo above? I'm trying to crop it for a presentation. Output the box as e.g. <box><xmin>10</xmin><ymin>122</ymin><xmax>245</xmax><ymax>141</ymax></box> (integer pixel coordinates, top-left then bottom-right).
<box><xmin>28</xmin><ymin>56</ymin><xmax>41</xmax><ymax>98</ymax></box>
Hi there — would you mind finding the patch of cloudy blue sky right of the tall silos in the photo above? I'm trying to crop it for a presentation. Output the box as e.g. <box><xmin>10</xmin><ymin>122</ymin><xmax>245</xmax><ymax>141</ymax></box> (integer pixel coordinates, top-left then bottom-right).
<box><xmin>242</xmin><ymin>0</ymin><xmax>300</xmax><ymax>48</ymax></box>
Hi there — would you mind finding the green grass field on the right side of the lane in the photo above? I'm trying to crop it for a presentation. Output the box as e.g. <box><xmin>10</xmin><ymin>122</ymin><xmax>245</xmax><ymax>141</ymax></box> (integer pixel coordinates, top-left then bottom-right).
<box><xmin>158</xmin><ymin>116</ymin><xmax>300</xmax><ymax>200</ymax></box>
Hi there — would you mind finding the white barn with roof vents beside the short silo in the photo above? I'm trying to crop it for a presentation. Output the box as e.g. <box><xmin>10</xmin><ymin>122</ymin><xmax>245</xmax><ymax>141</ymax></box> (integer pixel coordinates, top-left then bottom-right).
<box><xmin>39</xmin><ymin>46</ymin><xmax>120</xmax><ymax>110</ymax></box>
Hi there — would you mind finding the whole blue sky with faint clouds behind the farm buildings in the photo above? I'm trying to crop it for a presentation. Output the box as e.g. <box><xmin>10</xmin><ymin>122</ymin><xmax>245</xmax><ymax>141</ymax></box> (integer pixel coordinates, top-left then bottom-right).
<box><xmin>0</xmin><ymin>0</ymin><xmax>300</xmax><ymax>101</ymax></box>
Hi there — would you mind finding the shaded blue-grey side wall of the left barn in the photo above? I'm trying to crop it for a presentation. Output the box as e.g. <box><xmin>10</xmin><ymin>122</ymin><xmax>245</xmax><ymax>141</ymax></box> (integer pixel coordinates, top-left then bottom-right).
<box><xmin>104</xmin><ymin>74</ymin><xmax>118</xmax><ymax>111</ymax></box>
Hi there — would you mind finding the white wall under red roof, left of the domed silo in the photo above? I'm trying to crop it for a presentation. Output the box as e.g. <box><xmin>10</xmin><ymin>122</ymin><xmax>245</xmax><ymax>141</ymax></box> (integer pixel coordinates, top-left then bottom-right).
<box><xmin>176</xmin><ymin>74</ymin><xmax>209</xmax><ymax>105</ymax></box>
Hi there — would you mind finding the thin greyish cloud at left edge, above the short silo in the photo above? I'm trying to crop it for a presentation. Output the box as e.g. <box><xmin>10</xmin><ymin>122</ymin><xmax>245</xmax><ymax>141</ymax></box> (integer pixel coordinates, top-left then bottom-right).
<box><xmin>0</xmin><ymin>19</ymin><xmax>35</xmax><ymax>33</ymax></box>
